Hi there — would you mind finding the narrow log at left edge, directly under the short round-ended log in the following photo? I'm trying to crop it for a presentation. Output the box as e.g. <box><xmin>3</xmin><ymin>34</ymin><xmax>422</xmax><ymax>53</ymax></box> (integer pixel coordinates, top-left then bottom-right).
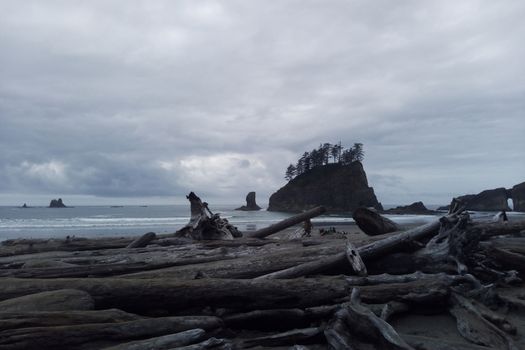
<box><xmin>0</xmin><ymin>309</ymin><xmax>143</xmax><ymax>330</ymax></box>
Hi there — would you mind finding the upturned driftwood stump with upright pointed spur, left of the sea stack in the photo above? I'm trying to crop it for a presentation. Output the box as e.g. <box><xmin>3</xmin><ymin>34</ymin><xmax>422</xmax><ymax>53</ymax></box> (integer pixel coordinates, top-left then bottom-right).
<box><xmin>175</xmin><ymin>192</ymin><xmax>242</xmax><ymax>240</ymax></box>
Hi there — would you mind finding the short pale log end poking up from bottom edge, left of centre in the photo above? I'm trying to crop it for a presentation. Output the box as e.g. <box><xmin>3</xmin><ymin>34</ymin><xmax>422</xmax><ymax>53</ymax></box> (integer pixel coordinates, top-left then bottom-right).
<box><xmin>99</xmin><ymin>328</ymin><xmax>206</xmax><ymax>350</ymax></box>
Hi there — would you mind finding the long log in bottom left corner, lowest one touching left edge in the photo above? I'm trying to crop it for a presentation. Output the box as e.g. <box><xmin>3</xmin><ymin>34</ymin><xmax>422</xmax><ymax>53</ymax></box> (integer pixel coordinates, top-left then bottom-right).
<box><xmin>0</xmin><ymin>316</ymin><xmax>222</xmax><ymax>350</ymax></box>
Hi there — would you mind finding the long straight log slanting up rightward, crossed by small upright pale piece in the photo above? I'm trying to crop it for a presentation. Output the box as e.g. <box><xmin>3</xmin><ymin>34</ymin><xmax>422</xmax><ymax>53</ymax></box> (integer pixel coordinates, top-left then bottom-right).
<box><xmin>258</xmin><ymin>220</ymin><xmax>440</xmax><ymax>279</ymax></box>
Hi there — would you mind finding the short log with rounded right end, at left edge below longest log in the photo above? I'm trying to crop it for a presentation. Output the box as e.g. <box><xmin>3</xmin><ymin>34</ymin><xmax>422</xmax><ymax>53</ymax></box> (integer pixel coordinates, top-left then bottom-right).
<box><xmin>0</xmin><ymin>290</ymin><xmax>94</xmax><ymax>312</ymax></box>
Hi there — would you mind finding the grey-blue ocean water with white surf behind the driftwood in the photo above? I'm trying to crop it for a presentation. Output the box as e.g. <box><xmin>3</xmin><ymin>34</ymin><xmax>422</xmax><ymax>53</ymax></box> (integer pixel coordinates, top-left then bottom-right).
<box><xmin>0</xmin><ymin>204</ymin><xmax>520</xmax><ymax>241</ymax></box>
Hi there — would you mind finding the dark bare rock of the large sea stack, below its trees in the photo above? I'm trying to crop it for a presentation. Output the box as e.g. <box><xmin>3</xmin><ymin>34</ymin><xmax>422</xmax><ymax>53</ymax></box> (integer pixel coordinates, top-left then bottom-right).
<box><xmin>268</xmin><ymin>162</ymin><xmax>383</xmax><ymax>212</ymax></box>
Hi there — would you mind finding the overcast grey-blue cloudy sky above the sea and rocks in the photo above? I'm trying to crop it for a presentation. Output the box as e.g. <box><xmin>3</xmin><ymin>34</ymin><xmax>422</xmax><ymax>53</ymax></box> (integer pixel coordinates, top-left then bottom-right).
<box><xmin>0</xmin><ymin>0</ymin><xmax>525</xmax><ymax>206</ymax></box>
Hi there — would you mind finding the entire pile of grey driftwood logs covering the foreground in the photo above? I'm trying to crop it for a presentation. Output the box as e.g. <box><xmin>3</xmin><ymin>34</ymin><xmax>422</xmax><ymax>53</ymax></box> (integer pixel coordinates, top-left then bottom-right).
<box><xmin>0</xmin><ymin>194</ymin><xmax>525</xmax><ymax>350</ymax></box>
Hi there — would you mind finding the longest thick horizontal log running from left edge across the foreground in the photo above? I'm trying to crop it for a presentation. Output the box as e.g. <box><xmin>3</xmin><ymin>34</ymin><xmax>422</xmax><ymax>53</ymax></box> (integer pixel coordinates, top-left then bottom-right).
<box><xmin>0</xmin><ymin>276</ymin><xmax>459</xmax><ymax>315</ymax></box>
